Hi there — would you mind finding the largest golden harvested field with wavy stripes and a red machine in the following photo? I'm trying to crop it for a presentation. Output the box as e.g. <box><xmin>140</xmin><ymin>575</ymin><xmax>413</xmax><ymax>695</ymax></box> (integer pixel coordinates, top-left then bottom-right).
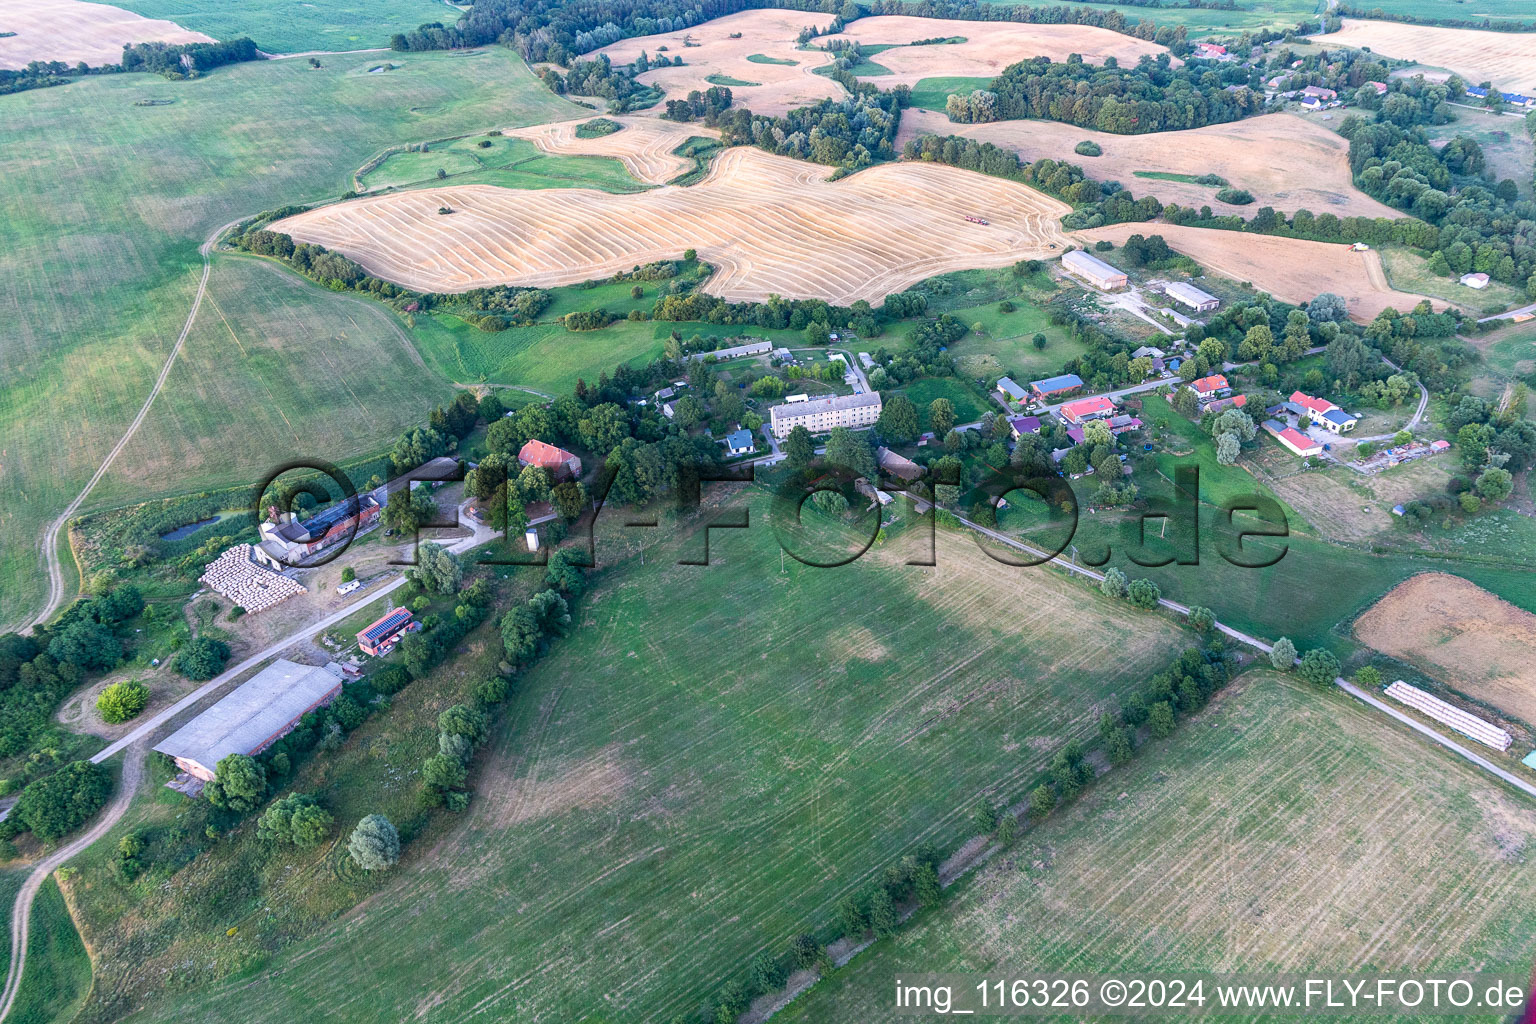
<box><xmin>272</xmin><ymin>145</ymin><xmax>1069</xmax><ymax>302</ymax></box>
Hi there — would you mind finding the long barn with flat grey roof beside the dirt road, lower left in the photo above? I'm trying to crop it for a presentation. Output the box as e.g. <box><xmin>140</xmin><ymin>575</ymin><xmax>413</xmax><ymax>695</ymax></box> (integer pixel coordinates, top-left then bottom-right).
<box><xmin>155</xmin><ymin>659</ymin><xmax>341</xmax><ymax>781</ymax></box>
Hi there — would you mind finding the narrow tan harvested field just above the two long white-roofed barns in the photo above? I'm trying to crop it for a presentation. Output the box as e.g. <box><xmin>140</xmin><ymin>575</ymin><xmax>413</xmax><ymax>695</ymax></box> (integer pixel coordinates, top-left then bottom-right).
<box><xmin>1078</xmin><ymin>223</ymin><xmax>1447</xmax><ymax>322</ymax></box>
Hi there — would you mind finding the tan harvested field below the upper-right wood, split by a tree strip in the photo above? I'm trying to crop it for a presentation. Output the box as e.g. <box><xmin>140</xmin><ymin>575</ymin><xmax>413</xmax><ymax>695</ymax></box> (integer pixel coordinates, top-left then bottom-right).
<box><xmin>897</xmin><ymin>109</ymin><xmax>1402</xmax><ymax>218</ymax></box>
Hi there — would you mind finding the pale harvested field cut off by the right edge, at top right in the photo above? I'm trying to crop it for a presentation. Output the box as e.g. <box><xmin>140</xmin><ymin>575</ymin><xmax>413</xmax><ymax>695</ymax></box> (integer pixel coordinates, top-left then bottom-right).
<box><xmin>1316</xmin><ymin>18</ymin><xmax>1536</xmax><ymax>92</ymax></box>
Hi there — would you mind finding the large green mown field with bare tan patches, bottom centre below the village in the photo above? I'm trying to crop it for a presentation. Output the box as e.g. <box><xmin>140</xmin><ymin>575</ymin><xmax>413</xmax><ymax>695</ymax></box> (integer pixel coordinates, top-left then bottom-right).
<box><xmin>102</xmin><ymin>503</ymin><xmax>1187</xmax><ymax>1024</ymax></box>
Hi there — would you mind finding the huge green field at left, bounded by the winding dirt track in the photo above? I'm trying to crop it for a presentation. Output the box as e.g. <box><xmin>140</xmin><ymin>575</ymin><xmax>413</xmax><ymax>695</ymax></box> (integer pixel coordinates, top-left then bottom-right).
<box><xmin>0</xmin><ymin>48</ymin><xmax>581</xmax><ymax>623</ymax></box>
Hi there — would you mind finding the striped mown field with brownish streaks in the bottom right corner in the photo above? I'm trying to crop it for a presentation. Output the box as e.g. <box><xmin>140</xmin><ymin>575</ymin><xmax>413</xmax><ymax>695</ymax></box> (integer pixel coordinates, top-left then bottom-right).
<box><xmin>776</xmin><ymin>672</ymin><xmax>1536</xmax><ymax>1022</ymax></box>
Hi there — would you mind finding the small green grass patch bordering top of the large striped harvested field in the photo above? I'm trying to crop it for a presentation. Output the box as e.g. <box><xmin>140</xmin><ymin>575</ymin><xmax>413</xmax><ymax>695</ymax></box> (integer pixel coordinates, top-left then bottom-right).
<box><xmin>361</xmin><ymin>135</ymin><xmax>645</xmax><ymax>192</ymax></box>
